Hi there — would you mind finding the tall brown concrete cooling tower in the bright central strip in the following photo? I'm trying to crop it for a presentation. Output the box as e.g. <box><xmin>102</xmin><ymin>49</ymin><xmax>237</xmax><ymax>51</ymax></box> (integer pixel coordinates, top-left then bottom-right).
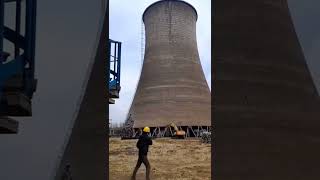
<box><xmin>127</xmin><ymin>0</ymin><xmax>211</xmax><ymax>136</ymax></box>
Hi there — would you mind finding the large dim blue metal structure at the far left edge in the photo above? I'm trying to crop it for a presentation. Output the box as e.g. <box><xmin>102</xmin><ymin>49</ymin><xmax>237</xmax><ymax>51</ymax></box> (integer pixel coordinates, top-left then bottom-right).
<box><xmin>0</xmin><ymin>0</ymin><xmax>36</xmax><ymax>132</ymax></box>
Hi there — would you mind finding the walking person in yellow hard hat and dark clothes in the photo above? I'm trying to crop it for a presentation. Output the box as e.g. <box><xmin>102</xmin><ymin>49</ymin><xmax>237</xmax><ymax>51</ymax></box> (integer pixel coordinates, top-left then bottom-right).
<box><xmin>131</xmin><ymin>127</ymin><xmax>152</xmax><ymax>180</ymax></box>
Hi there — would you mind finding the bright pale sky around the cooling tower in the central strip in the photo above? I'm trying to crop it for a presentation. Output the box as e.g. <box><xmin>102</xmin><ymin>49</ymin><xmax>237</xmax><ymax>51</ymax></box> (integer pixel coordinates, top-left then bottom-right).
<box><xmin>109</xmin><ymin>0</ymin><xmax>211</xmax><ymax>123</ymax></box>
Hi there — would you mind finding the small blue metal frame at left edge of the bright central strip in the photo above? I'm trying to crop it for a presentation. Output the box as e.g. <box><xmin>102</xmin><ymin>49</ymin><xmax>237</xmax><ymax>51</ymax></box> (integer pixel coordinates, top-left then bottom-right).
<box><xmin>108</xmin><ymin>39</ymin><xmax>121</xmax><ymax>104</ymax></box>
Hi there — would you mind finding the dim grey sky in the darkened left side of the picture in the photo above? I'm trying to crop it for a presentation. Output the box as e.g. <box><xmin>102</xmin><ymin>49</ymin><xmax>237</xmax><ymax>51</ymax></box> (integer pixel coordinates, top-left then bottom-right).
<box><xmin>0</xmin><ymin>0</ymin><xmax>107</xmax><ymax>180</ymax></box>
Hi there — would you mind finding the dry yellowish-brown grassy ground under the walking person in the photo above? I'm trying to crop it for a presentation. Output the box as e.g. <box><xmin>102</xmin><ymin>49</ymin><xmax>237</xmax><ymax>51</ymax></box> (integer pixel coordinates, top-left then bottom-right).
<box><xmin>109</xmin><ymin>138</ymin><xmax>211</xmax><ymax>180</ymax></box>
